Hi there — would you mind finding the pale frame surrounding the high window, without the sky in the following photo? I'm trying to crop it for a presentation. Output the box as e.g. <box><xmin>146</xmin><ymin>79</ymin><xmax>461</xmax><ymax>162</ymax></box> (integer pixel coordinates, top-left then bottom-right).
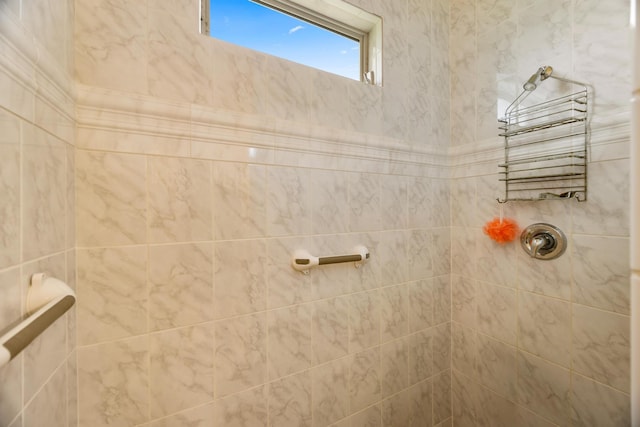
<box><xmin>200</xmin><ymin>0</ymin><xmax>382</xmax><ymax>86</ymax></box>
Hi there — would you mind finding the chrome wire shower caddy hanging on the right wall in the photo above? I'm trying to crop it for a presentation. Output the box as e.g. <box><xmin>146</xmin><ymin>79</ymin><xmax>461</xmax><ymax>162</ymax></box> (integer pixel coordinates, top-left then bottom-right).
<box><xmin>498</xmin><ymin>66</ymin><xmax>589</xmax><ymax>203</ymax></box>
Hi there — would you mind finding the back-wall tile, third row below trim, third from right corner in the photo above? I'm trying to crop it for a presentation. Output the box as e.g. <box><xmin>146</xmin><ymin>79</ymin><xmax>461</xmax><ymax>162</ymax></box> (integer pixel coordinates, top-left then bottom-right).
<box><xmin>380</xmin><ymin>285</ymin><xmax>409</xmax><ymax>342</ymax></box>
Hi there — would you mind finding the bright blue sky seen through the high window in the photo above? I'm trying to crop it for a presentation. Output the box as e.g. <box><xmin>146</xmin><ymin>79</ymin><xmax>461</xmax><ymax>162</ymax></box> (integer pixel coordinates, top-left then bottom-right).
<box><xmin>209</xmin><ymin>0</ymin><xmax>360</xmax><ymax>80</ymax></box>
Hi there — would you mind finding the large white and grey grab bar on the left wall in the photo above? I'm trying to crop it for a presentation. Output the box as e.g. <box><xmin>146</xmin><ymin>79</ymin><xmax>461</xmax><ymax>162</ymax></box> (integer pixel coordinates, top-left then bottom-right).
<box><xmin>0</xmin><ymin>273</ymin><xmax>76</xmax><ymax>367</ymax></box>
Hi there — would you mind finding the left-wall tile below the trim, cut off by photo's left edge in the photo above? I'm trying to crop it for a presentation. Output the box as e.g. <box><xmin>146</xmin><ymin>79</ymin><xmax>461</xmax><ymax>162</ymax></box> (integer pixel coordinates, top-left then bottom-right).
<box><xmin>0</xmin><ymin>111</ymin><xmax>20</xmax><ymax>268</ymax></box>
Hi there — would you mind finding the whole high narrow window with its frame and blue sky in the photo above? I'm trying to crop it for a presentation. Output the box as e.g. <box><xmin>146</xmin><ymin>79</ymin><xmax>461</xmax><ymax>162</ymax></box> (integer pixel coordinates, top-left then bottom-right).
<box><xmin>200</xmin><ymin>0</ymin><xmax>382</xmax><ymax>85</ymax></box>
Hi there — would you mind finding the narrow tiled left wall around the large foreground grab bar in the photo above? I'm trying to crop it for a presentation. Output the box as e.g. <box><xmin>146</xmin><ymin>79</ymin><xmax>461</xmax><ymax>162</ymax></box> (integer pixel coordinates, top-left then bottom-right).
<box><xmin>0</xmin><ymin>0</ymin><xmax>77</xmax><ymax>427</ymax></box>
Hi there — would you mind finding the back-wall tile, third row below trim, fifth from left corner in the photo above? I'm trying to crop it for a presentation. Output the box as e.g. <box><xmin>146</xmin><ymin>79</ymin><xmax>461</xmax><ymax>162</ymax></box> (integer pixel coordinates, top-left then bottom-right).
<box><xmin>311</xmin><ymin>297</ymin><xmax>348</xmax><ymax>364</ymax></box>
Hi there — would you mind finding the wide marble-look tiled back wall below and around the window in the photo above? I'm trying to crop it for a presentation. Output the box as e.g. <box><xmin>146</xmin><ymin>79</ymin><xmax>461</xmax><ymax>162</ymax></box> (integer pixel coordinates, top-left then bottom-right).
<box><xmin>75</xmin><ymin>0</ymin><xmax>451</xmax><ymax>427</ymax></box>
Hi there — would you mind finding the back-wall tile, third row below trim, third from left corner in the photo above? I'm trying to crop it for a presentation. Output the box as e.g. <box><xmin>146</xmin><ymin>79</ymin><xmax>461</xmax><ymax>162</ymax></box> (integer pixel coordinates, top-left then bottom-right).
<box><xmin>214</xmin><ymin>314</ymin><xmax>267</xmax><ymax>396</ymax></box>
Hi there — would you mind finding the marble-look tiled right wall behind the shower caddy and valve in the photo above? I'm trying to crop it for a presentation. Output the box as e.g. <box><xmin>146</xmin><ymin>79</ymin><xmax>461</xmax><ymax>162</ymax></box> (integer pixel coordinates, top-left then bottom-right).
<box><xmin>450</xmin><ymin>0</ymin><xmax>631</xmax><ymax>426</ymax></box>
